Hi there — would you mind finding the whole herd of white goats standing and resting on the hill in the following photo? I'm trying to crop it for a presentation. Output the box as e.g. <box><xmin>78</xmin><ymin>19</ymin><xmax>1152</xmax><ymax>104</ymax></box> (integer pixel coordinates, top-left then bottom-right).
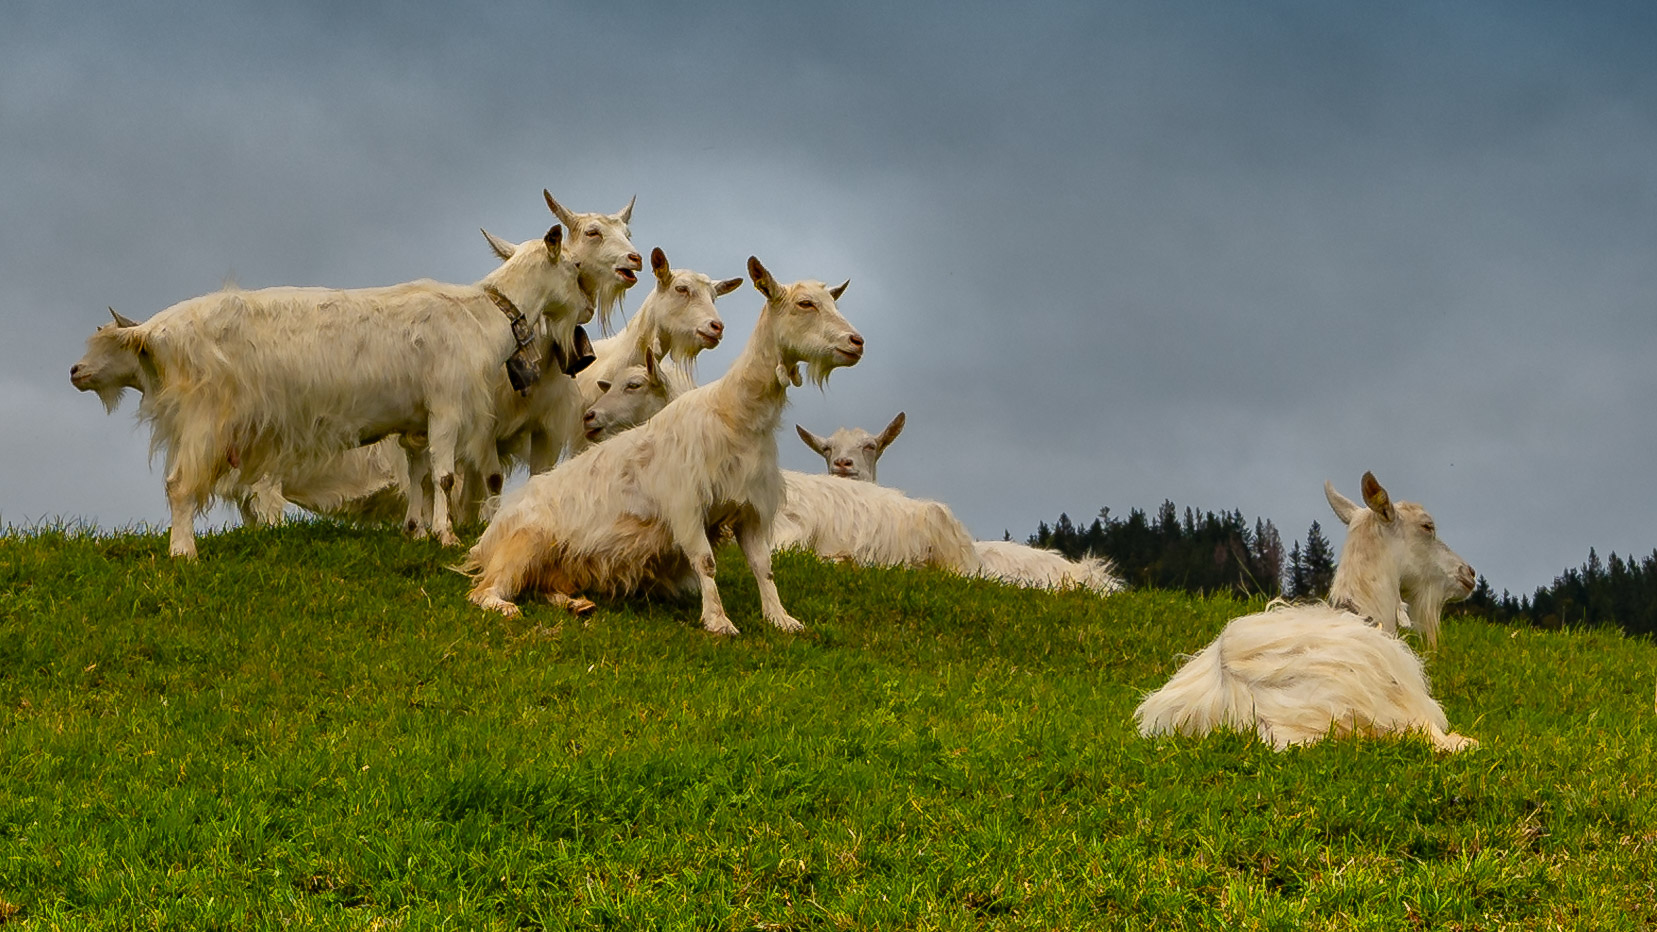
<box><xmin>70</xmin><ymin>192</ymin><xmax>1475</xmax><ymax>751</ymax></box>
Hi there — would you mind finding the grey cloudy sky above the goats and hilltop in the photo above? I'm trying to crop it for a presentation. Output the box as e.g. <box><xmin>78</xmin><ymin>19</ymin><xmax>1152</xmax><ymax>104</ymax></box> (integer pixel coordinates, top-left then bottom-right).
<box><xmin>0</xmin><ymin>0</ymin><xmax>1657</xmax><ymax>592</ymax></box>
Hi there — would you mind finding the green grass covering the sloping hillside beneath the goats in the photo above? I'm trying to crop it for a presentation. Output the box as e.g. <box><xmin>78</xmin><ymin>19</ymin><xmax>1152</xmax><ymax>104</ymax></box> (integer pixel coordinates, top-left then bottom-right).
<box><xmin>0</xmin><ymin>524</ymin><xmax>1657</xmax><ymax>930</ymax></box>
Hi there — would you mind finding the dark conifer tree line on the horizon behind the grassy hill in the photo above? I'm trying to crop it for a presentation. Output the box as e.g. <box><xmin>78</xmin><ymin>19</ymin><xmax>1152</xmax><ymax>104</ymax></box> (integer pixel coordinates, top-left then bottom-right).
<box><xmin>1027</xmin><ymin>501</ymin><xmax>1657</xmax><ymax>635</ymax></box>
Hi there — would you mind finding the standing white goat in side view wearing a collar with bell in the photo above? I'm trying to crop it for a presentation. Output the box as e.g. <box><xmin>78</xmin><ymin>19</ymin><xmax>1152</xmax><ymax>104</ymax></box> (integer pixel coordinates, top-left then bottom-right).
<box><xmin>89</xmin><ymin>213</ymin><xmax>590</xmax><ymax>557</ymax></box>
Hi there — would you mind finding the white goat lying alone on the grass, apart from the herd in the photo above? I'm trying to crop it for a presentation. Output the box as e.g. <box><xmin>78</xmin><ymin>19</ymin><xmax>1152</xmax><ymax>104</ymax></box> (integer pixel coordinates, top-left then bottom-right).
<box><xmin>1133</xmin><ymin>473</ymin><xmax>1476</xmax><ymax>751</ymax></box>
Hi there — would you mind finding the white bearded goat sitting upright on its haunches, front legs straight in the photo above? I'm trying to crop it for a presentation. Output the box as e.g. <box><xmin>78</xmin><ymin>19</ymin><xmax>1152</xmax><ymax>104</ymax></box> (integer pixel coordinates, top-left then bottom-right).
<box><xmin>466</xmin><ymin>257</ymin><xmax>863</xmax><ymax>633</ymax></box>
